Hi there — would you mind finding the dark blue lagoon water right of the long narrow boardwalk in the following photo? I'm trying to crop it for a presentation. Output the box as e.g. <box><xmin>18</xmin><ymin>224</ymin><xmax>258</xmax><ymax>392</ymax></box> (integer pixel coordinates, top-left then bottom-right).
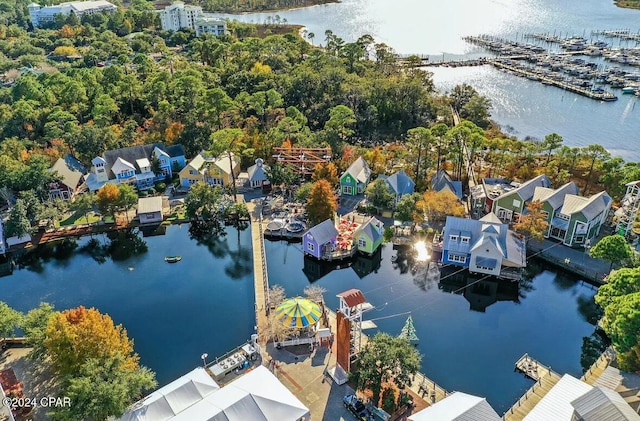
<box><xmin>265</xmin><ymin>241</ymin><xmax>595</xmax><ymax>413</ymax></box>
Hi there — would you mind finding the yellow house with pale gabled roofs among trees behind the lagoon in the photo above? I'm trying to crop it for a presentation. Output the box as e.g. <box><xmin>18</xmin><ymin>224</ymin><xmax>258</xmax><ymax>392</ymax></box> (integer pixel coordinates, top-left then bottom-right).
<box><xmin>180</xmin><ymin>152</ymin><xmax>240</xmax><ymax>188</ymax></box>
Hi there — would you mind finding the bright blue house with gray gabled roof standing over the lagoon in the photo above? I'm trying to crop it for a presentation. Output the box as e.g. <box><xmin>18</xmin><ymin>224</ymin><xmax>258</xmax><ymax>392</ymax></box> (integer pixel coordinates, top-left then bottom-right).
<box><xmin>441</xmin><ymin>213</ymin><xmax>526</xmax><ymax>278</ymax></box>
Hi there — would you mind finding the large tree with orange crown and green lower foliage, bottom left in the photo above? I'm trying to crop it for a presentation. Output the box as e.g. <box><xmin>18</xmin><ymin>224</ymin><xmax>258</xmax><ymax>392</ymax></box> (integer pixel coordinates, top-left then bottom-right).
<box><xmin>43</xmin><ymin>306</ymin><xmax>157</xmax><ymax>420</ymax></box>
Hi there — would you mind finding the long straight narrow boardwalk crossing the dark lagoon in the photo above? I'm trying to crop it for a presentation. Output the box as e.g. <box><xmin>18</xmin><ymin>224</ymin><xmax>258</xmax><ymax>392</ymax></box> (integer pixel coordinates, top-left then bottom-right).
<box><xmin>247</xmin><ymin>202</ymin><xmax>269</xmax><ymax>334</ymax></box>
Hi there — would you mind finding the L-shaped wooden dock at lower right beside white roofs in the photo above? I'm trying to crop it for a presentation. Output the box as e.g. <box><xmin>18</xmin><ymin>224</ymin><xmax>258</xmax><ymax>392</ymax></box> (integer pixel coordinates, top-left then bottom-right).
<box><xmin>502</xmin><ymin>354</ymin><xmax>560</xmax><ymax>421</ymax></box>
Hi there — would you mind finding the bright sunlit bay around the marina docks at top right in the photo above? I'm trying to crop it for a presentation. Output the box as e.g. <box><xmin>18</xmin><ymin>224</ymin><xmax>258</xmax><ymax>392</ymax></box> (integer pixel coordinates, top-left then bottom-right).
<box><xmin>226</xmin><ymin>0</ymin><xmax>640</xmax><ymax>161</ymax></box>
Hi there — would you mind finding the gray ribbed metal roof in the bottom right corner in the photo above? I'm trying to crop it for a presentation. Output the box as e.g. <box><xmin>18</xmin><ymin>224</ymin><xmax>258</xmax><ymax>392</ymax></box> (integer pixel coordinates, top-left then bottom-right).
<box><xmin>571</xmin><ymin>387</ymin><xmax>640</xmax><ymax>421</ymax></box>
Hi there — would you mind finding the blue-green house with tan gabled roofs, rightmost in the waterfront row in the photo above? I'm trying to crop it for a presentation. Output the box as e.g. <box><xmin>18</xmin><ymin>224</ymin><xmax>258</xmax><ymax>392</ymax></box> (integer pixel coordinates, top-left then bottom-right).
<box><xmin>533</xmin><ymin>182</ymin><xmax>612</xmax><ymax>247</ymax></box>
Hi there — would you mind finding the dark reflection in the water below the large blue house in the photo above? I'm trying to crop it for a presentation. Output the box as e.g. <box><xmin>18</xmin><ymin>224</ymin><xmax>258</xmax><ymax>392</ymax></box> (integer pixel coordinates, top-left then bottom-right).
<box><xmin>438</xmin><ymin>271</ymin><xmax>520</xmax><ymax>313</ymax></box>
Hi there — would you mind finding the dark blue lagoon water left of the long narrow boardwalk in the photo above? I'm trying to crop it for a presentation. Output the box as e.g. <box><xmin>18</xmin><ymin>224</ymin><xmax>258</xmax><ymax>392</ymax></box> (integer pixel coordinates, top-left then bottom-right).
<box><xmin>0</xmin><ymin>224</ymin><xmax>255</xmax><ymax>385</ymax></box>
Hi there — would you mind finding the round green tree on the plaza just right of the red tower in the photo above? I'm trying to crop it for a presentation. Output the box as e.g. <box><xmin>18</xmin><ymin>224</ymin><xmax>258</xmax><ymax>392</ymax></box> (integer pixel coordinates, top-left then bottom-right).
<box><xmin>352</xmin><ymin>333</ymin><xmax>422</xmax><ymax>402</ymax></box>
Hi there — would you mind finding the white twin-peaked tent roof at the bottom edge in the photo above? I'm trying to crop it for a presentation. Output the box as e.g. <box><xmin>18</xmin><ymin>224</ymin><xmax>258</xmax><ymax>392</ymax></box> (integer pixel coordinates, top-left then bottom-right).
<box><xmin>118</xmin><ymin>366</ymin><xmax>310</xmax><ymax>421</ymax></box>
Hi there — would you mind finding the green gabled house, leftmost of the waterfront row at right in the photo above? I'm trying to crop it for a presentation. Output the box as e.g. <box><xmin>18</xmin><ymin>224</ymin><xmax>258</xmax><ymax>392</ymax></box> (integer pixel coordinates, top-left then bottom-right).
<box><xmin>492</xmin><ymin>174</ymin><xmax>551</xmax><ymax>223</ymax></box>
